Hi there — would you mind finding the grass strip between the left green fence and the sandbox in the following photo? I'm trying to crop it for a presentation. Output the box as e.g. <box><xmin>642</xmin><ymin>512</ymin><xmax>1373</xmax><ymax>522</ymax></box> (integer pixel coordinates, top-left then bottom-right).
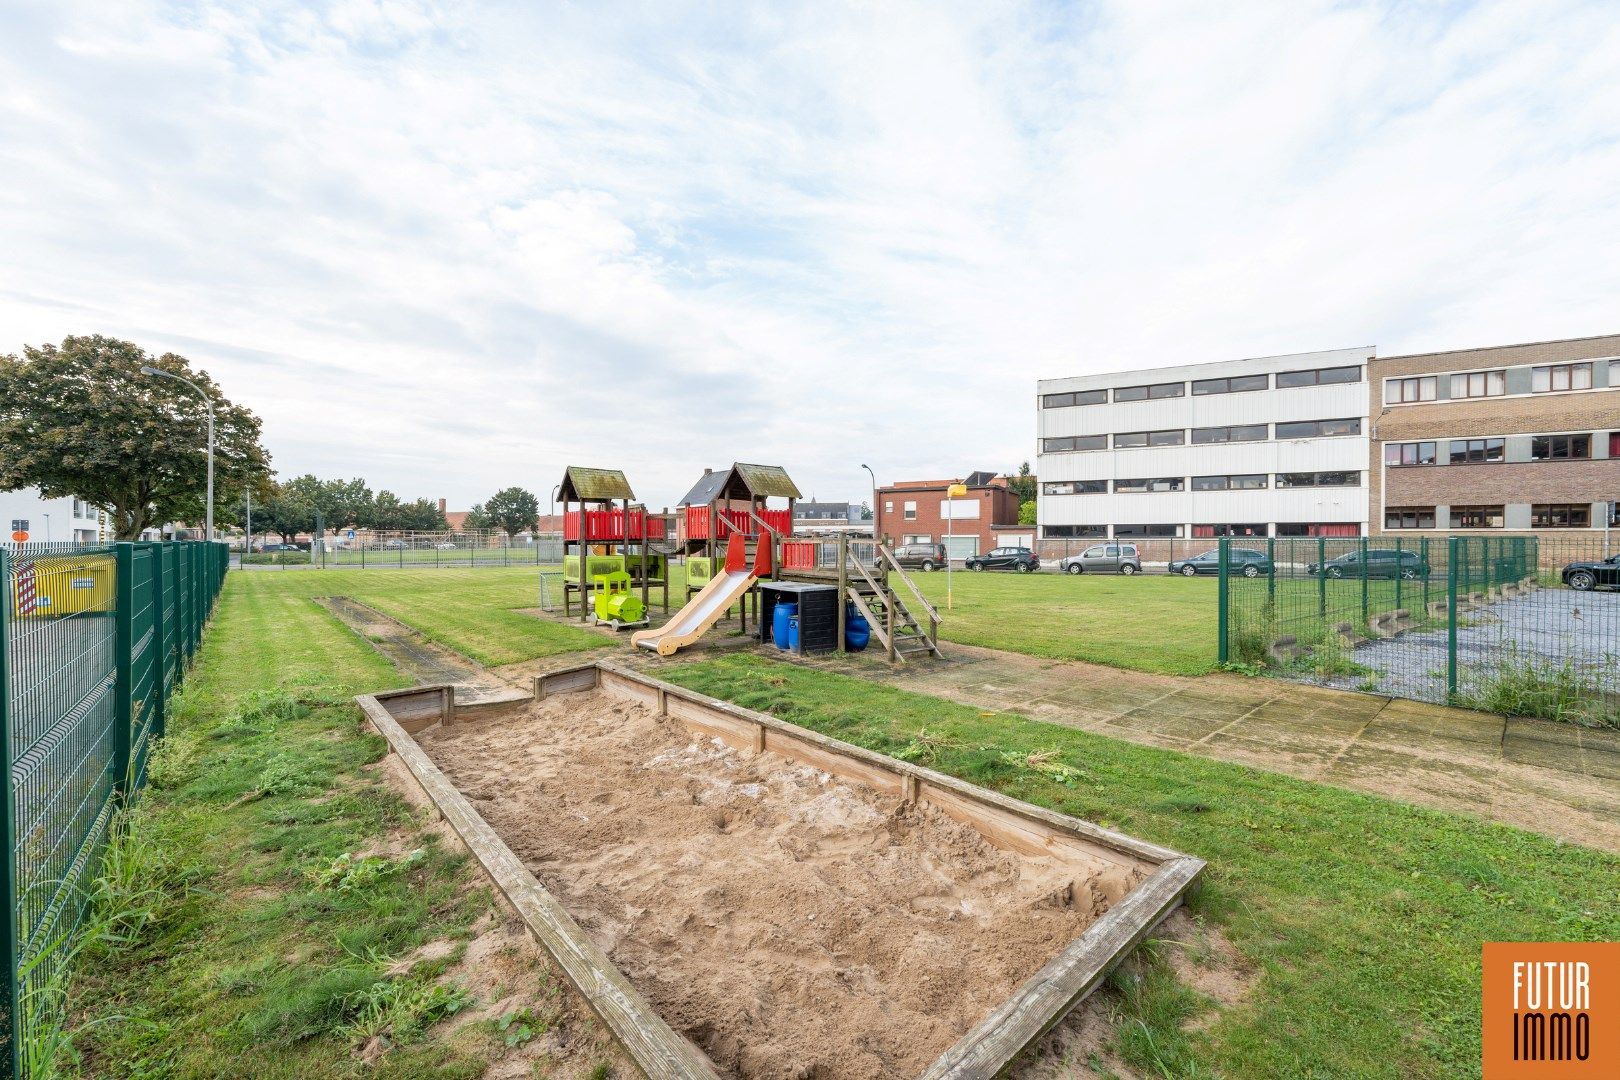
<box><xmin>61</xmin><ymin>572</ymin><xmax>606</xmax><ymax>1078</ymax></box>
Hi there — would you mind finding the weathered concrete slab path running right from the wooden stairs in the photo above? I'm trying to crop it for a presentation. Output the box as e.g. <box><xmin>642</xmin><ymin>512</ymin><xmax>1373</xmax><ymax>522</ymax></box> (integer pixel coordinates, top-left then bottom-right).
<box><xmin>790</xmin><ymin>644</ymin><xmax>1620</xmax><ymax>852</ymax></box>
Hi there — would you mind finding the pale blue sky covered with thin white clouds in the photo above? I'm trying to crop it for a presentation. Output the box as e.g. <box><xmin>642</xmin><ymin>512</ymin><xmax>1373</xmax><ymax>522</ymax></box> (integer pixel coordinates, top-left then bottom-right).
<box><xmin>0</xmin><ymin>0</ymin><xmax>1620</xmax><ymax>508</ymax></box>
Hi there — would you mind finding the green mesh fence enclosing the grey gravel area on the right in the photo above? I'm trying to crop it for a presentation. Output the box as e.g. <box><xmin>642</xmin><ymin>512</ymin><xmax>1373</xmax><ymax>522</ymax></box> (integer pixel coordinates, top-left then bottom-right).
<box><xmin>1218</xmin><ymin>536</ymin><xmax>1620</xmax><ymax>725</ymax></box>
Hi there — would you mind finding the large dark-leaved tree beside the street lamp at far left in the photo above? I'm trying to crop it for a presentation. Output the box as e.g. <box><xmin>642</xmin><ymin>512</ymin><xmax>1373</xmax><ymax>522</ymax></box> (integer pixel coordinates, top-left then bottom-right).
<box><xmin>0</xmin><ymin>334</ymin><xmax>269</xmax><ymax>539</ymax></box>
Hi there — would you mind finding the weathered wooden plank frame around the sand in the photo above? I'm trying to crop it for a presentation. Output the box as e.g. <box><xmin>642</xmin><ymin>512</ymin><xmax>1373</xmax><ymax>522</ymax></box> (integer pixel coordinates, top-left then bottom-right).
<box><xmin>356</xmin><ymin>662</ymin><xmax>1204</xmax><ymax>1080</ymax></box>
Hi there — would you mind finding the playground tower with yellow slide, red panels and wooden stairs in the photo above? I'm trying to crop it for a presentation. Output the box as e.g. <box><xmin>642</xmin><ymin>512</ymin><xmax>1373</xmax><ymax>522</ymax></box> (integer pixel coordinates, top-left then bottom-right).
<box><xmin>632</xmin><ymin>461</ymin><xmax>941</xmax><ymax>662</ymax></box>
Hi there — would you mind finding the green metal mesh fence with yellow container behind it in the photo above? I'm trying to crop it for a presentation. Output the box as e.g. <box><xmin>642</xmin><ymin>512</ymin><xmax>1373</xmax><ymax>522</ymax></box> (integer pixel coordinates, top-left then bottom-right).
<box><xmin>0</xmin><ymin>542</ymin><xmax>227</xmax><ymax>1077</ymax></box>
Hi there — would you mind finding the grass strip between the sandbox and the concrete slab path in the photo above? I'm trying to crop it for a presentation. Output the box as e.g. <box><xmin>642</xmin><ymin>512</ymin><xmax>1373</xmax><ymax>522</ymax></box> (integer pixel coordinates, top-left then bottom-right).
<box><xmin>659</xmin><ymin>654</ymin><xmax>1620</xmax><ymax>1080</ymax></box>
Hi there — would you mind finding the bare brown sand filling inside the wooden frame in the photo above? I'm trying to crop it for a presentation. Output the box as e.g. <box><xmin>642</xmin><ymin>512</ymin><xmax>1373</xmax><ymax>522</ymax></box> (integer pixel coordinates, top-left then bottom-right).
<box><xmin>420</xmin><ymin>693</ymin><xmax>1140</xmax><ymax>1078</ymax></box>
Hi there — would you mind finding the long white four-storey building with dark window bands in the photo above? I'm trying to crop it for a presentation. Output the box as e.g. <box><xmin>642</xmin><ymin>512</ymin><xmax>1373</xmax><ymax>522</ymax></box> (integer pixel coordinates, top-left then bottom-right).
<box><xmin>1035</xmin><ymin>347</ymin><xmax>1374</xmax><ymax>539</ymax></box>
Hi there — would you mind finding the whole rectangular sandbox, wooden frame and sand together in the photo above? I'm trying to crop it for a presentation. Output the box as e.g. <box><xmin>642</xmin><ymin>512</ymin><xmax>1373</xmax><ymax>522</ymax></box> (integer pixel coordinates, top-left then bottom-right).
<box><xmin>360</xmin><ymin>664</ymin><xmax>1202</xmax><ymax>1078</ymax></box>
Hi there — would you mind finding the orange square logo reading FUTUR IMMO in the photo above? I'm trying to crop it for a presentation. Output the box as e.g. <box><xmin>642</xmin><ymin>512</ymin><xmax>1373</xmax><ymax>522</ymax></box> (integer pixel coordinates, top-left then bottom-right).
<box><xmin>1482</xmin><ymin>941</ymin><xmax>1620</xmax><ymax>1080</ymax></box>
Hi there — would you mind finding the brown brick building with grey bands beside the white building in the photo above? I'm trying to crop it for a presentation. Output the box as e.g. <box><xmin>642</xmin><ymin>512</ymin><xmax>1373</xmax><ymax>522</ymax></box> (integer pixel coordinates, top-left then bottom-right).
<box><xmin>1367</xmin><ymin>335</ymin><xmax>1620</xmax><ymax>544</ymax></box>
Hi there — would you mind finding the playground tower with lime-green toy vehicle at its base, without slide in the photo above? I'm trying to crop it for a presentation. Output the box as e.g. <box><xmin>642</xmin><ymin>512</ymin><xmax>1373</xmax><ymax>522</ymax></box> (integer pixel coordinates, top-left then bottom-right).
<box><xmin>557</xmin><ymin>465</ymin><xmax>674</xmax><ymax>630</ymax></box>
